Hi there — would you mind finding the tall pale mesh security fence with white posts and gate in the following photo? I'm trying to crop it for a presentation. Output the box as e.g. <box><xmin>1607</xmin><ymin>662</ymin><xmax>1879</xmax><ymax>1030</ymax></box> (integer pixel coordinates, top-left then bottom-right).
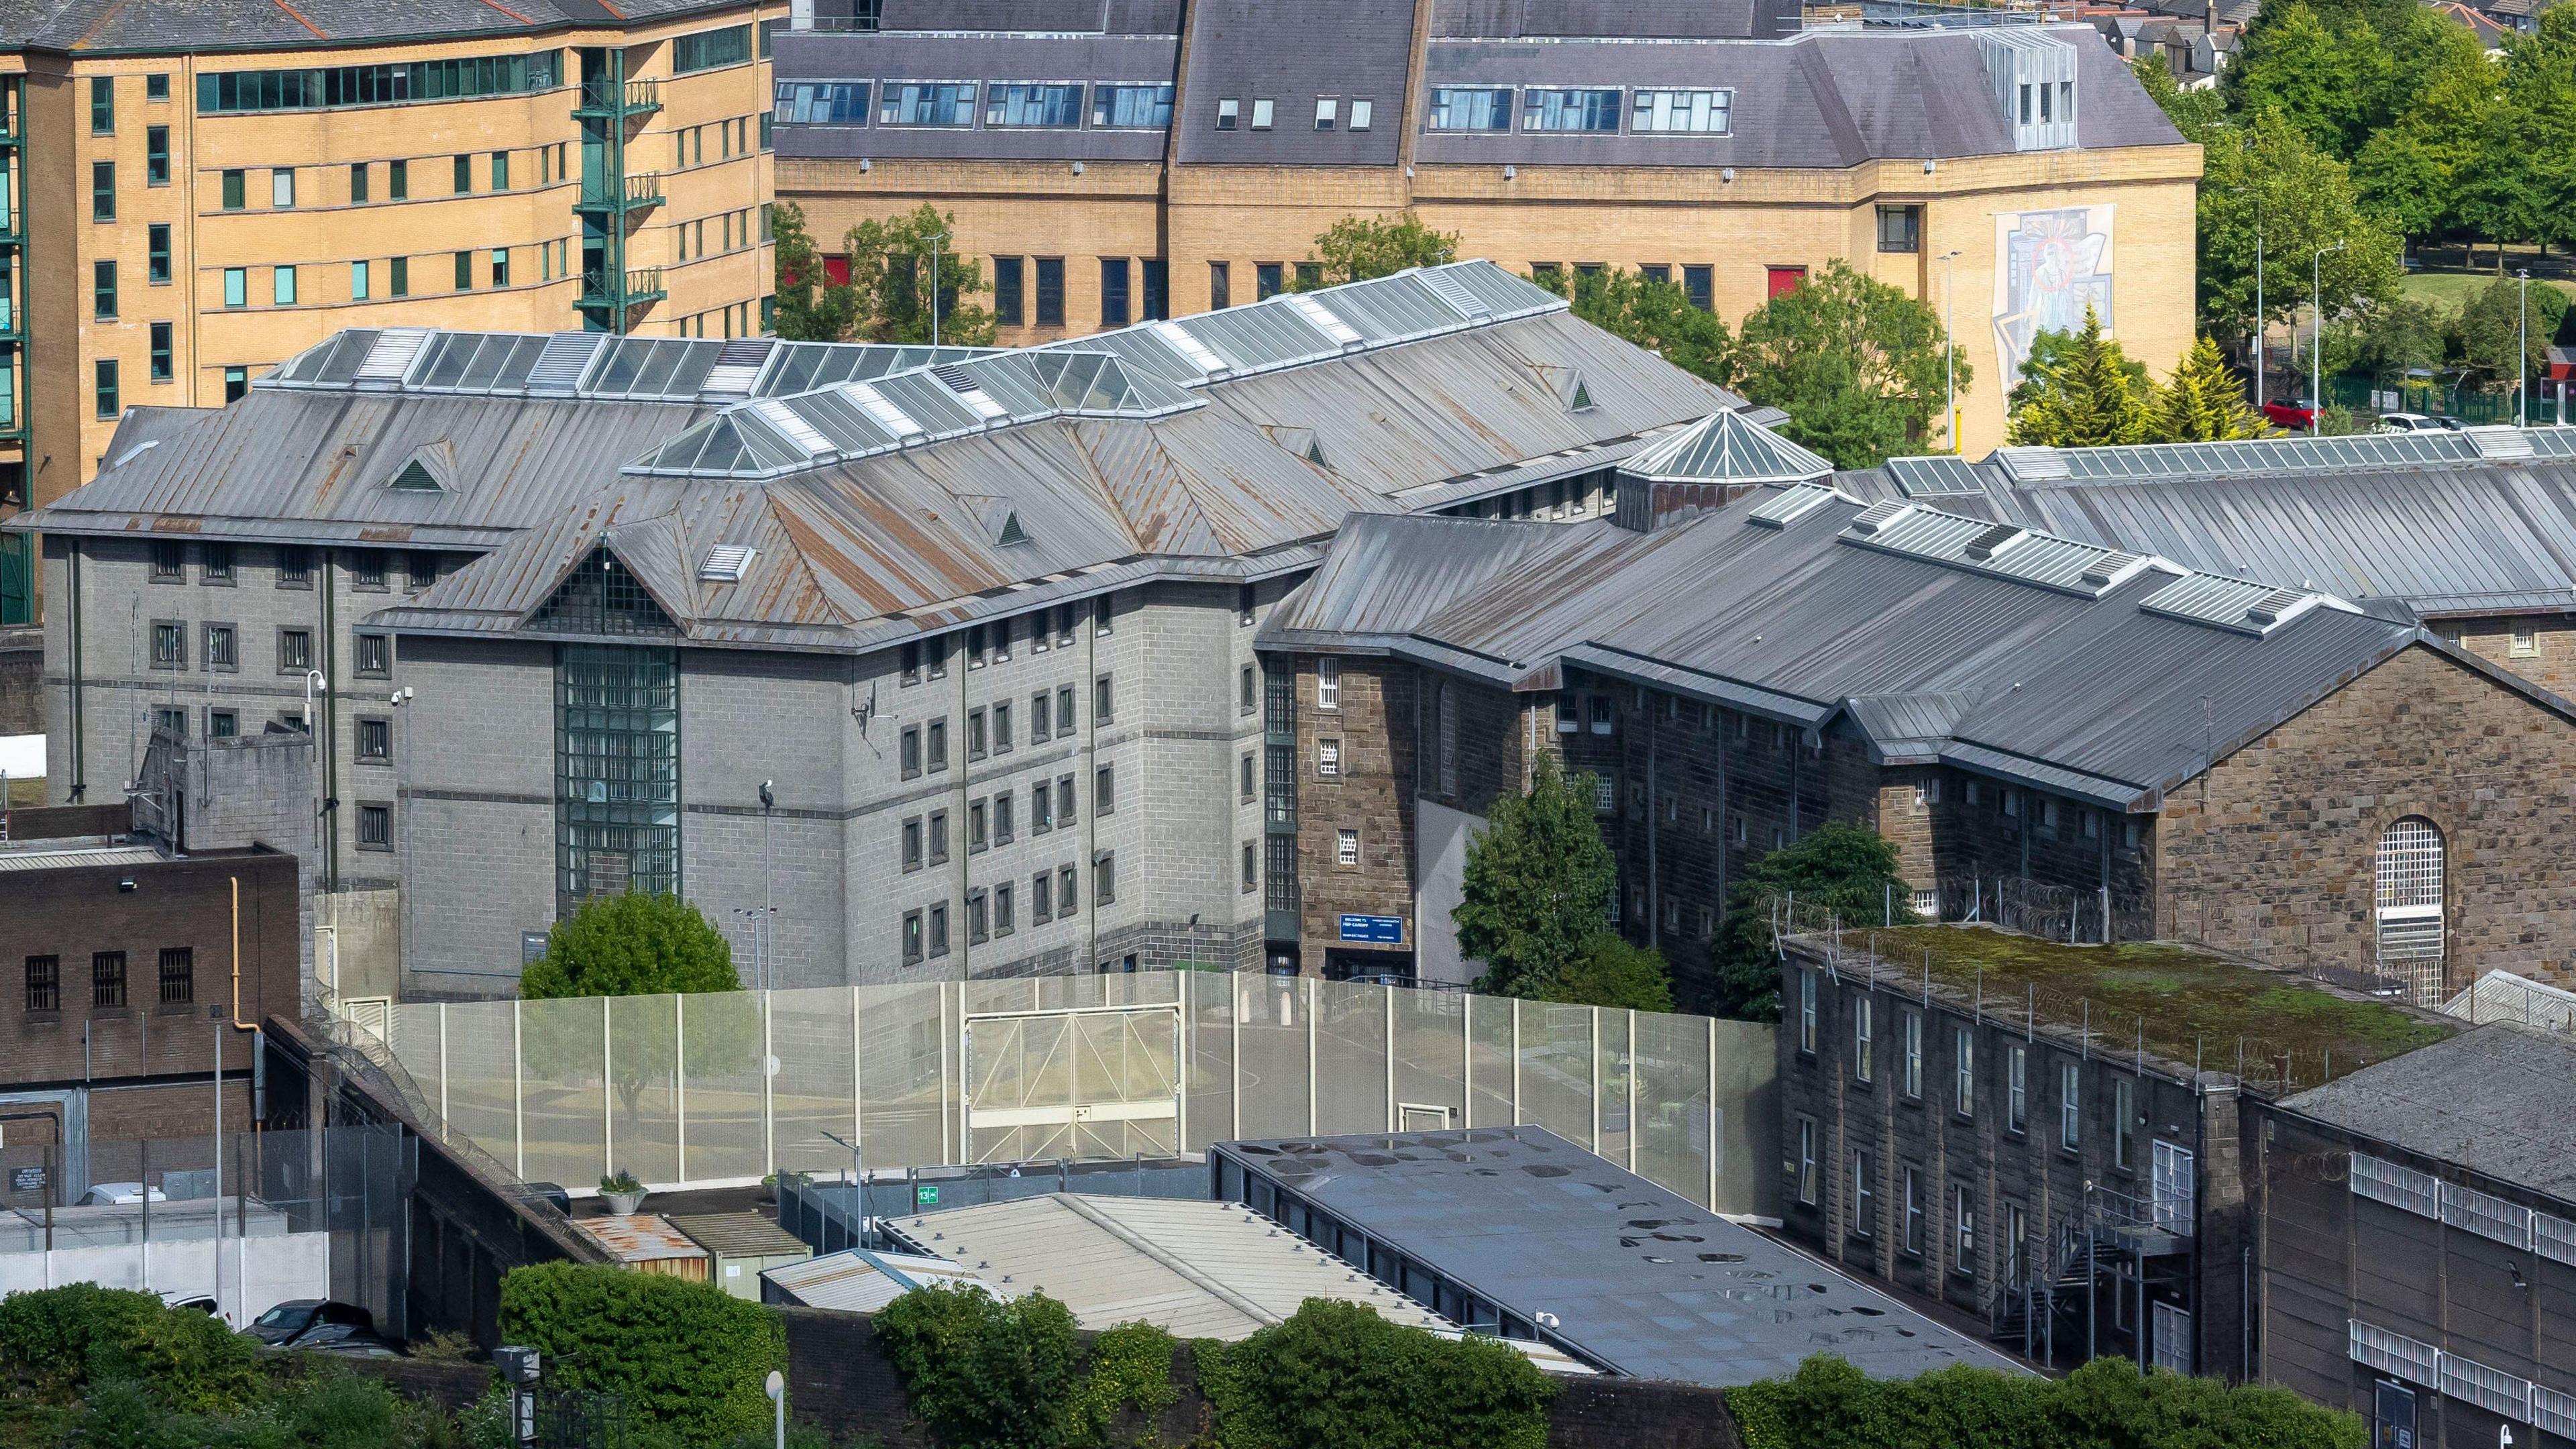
<box><xmin>368</xmin><ymin>972</ymin><xmax>1778</xmax><ymax>1212</ymax></box>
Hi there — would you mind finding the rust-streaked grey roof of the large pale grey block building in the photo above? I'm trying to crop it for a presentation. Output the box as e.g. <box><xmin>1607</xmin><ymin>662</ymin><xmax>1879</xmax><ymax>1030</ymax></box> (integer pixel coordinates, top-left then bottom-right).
<box><xmin>8</xmin><ymin>263</ymin><xmax>1741</xmax><ymax>650</ymax></box>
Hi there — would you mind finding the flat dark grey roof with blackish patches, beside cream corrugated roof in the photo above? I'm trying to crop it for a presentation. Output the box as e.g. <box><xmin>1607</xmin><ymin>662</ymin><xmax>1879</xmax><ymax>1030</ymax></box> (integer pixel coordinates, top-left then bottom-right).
<box><xmin>1216</xmin><ymin>1127</ymin><xmax>2027</xmax><ymax>1387</ymax></box>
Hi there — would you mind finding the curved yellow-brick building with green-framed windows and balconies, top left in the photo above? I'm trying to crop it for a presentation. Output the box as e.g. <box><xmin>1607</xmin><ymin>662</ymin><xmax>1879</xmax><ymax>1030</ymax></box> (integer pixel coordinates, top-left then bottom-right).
<box><xmin>0</xmin><ymin>0</ymin><xmax>786</xmax><ymax>613</ymax></box>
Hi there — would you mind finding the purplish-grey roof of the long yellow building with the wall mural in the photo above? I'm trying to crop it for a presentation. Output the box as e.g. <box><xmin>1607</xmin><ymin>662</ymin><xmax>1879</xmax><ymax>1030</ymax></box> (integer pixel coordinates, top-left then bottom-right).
<box><xmin>775</xmin><ymin>11</ymin><xmax>2187</xmax><ymax>168</ymax></box>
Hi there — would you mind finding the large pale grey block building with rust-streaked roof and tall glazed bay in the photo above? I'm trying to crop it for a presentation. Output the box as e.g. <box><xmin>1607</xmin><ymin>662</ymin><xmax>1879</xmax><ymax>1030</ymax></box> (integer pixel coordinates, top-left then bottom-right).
<box><xmin>13</xmin><ymin>263</ymin><xmax>1760</xmax><ymax>996</ymax></box>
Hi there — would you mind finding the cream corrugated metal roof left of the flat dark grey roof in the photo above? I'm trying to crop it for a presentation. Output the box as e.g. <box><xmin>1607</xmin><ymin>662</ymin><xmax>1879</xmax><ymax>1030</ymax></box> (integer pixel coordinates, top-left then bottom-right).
<box><xmin>892</xmin><ymin>1194</ymin><xmax>1456</xmax><ymax>1341</ymax></box>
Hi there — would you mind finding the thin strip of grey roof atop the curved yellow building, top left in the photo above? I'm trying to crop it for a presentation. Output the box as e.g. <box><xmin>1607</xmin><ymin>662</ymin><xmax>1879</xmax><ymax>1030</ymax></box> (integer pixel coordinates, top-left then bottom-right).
<box><xmin>0</xmin><ymin>0</ymin><xmax>747</xmax><ymax>54</ymax></box>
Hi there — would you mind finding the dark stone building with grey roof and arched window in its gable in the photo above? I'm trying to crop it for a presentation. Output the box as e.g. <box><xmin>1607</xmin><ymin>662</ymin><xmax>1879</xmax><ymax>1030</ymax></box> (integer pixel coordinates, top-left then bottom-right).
<box><xmin>1260</xmin><ymin>469</ymin><xmax>2576</xmax><ymax>1000</ymax></box>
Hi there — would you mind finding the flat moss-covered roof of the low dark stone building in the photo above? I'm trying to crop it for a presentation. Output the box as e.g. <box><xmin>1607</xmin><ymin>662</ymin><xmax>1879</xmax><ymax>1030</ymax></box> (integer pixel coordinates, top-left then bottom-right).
<box><xmin>1844</xmin><ymin>926</ymin><xmax>2453</xmax><ymax>1085</ymax></box>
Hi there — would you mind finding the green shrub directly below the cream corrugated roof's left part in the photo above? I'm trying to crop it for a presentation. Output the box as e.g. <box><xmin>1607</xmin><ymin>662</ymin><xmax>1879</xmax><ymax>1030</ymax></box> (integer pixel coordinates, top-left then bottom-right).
<box><xmin>876</xmin><ymin>1287</ymin><xmax>1081</xmax><ymax>1449</ymax></box>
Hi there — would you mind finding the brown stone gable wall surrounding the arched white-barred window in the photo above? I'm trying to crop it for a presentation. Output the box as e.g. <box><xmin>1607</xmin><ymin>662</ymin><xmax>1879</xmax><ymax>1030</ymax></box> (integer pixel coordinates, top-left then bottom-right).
<box><xmin>2156</xmin><ymin>645</ymin><xmax>2576</xmax><ymax>990</ymax></box>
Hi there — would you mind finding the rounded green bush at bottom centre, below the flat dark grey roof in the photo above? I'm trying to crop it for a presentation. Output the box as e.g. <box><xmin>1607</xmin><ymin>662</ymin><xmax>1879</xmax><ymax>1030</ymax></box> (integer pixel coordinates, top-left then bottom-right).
<box><xmin>1198</xmin><ymin>1299</ymin><xmax>1556</xmax><ymax>1449</ymax></box>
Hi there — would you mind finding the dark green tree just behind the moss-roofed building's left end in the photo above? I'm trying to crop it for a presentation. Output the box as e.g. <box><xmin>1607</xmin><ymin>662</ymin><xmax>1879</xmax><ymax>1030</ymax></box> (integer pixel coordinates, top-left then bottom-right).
<box><xmin>1715</xmin><ymin>820</ymin><xmax>1914</xmax><ymax>1021</ymax></box>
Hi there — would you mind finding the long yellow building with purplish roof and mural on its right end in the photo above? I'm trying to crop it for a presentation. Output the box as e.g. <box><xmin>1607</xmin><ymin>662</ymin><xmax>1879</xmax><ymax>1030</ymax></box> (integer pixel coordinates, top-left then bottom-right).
<box><xmin>775</xmin><ymin>0</ymin><xmax>2200</xmax><ymax>456</ymax></box>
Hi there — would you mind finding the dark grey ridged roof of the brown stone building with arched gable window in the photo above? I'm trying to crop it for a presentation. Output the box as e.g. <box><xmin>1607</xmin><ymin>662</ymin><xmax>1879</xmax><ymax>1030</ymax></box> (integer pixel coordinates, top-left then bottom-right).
<box><xmin>1263</xmin><ymin>490</ymin><xmax>2568</xmax><ymax>810</ymax></box>
